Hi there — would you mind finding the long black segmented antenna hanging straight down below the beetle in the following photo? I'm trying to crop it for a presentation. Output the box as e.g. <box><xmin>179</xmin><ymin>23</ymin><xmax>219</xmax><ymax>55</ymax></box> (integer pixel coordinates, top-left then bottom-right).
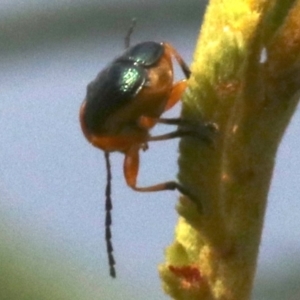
<box><xmin>104</xmin><ymin>152</ymin><xmax>116</xmax><ymax>278</ymax></box>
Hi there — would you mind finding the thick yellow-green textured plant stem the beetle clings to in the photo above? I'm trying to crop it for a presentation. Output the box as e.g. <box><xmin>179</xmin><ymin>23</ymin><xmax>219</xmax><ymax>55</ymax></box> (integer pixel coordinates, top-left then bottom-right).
<box><xmin>160</xmin><ymin>0</ymin><xmax>300</xmax><ymax>300</ymax></box>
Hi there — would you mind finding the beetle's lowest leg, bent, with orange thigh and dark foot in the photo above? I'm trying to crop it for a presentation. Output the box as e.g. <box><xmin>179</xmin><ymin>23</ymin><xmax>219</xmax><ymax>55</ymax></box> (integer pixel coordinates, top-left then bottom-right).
<box><xmin>124</xmin><ymin>147</ymin><xmax>190</xmax><ymax>197</ymax></box>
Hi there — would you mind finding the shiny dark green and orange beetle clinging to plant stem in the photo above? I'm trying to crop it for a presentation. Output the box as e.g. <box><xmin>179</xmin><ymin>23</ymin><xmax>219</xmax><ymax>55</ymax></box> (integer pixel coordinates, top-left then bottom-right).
<box><xmin>80</xmin><ymin>24</ymin><xmax>211</xmax><ymax>277</ymax></box>
